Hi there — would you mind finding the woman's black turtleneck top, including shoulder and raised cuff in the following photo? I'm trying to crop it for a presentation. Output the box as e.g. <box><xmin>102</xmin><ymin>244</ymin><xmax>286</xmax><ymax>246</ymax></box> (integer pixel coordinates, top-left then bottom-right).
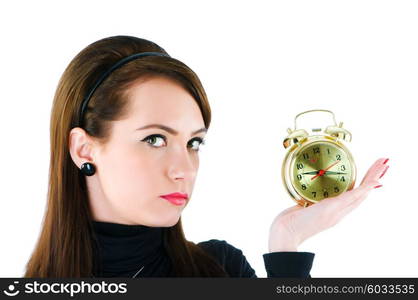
<box><xmin>92</xmin><ymin>221</ymin><xmax>315</xmax><ymax>278</ymax></box>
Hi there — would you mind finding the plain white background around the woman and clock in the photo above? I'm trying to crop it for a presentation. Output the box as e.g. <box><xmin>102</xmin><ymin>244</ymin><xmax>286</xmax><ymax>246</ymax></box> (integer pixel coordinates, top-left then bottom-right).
<box><xmin>0</xmin><ymin>0</ymin><xmax>418</xmax><ymax>277</ymax></box>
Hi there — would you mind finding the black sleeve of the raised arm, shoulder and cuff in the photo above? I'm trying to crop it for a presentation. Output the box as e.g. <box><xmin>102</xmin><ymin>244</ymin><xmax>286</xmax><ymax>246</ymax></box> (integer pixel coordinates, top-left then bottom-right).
<box><xmin>198</xmin><ymin>239</ymin><xmax>314</xmax><ymax>278</ymax></box>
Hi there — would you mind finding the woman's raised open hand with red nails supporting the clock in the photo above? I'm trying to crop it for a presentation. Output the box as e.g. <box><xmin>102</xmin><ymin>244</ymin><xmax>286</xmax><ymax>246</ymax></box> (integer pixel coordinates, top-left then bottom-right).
<box><xmin>268</xmin><ymin>158</ymin><xmax>389</xmax><ymax>252</ymax></box>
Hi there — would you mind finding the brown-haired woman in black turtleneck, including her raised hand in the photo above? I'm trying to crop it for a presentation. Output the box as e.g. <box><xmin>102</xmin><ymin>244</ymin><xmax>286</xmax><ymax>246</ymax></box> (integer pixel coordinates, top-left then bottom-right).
<box><xmin>25</xmin><ymin>36</ymin><xmax>386</xmax><ymax>277</ymax></box>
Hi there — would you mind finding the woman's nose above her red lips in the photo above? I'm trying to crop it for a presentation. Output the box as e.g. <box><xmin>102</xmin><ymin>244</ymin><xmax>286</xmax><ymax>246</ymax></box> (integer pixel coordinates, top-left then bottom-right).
<box><xmin>168</xmin><ymin>145</ymin><xmax>198</xmax><ymax>180</ymax></box>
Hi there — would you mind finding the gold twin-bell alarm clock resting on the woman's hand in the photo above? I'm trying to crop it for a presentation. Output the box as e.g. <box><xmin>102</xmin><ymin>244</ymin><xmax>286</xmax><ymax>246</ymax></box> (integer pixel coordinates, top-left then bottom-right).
<box><xmin>282</xmin><ymin>109</ymin><xmax>356</xmax><ymax>207</ymax></box>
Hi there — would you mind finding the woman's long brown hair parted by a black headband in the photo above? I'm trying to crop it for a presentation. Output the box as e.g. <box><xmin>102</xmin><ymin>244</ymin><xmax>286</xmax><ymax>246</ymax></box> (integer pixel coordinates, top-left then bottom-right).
<box><xmin>24</xmin><ymin>36</ymin><xmax>228</xmax><ymax>277</ymax></box>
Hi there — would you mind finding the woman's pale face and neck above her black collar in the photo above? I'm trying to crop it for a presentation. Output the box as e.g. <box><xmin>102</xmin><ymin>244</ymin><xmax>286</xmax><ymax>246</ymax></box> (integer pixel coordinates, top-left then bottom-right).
<box><xmin>71</xmin><ymin>77</ymin><xmax>205</xmax><ymax>227</ymax></box>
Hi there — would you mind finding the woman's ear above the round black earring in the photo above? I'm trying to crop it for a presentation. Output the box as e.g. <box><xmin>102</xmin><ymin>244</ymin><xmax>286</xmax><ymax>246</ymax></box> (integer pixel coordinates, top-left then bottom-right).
<box><xmin>68</xmin><ymin>127</ymin><xmax>94</xmax><ymax>169</ymax></box>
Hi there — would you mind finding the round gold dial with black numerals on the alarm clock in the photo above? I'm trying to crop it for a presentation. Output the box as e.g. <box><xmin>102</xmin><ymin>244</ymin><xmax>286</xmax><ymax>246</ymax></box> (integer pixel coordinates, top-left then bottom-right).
<box><xmin>291</xmin><ymin>141</ymin><xmax>353</xmax><ymax>201</ymax></box>
